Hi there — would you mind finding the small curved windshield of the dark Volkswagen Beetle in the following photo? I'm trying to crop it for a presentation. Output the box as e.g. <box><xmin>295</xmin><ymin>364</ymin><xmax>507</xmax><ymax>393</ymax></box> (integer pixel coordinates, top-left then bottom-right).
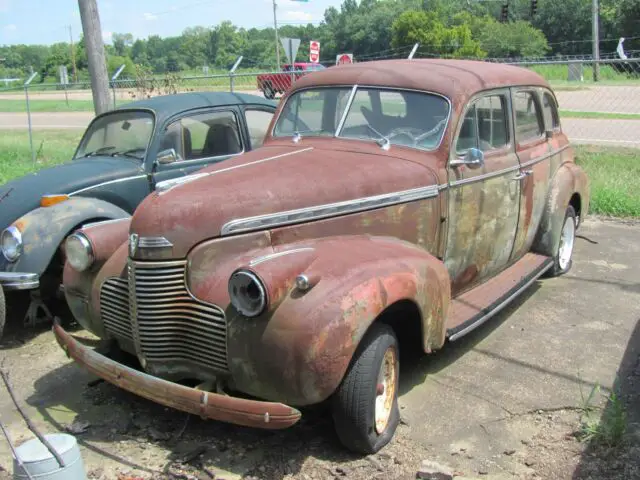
<box><xmin>75</xmin><ymin>111</ymin><xmax>154</xmax><ymax>160</ymax></box>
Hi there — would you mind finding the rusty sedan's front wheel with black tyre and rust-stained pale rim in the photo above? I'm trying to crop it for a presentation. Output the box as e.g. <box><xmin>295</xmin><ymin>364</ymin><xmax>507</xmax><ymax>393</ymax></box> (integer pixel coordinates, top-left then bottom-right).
<box><xmin>332</xmin><ymin>323</ymin><xmax>400</xmax><ymax>454</ymax></box>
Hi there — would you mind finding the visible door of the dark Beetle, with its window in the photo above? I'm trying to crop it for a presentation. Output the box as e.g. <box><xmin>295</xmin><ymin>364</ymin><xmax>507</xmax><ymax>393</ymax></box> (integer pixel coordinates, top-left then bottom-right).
<box><xmin>153</xmin><ymin>108</ymin><xmax>246</xmax><ymax>183</ymax></box>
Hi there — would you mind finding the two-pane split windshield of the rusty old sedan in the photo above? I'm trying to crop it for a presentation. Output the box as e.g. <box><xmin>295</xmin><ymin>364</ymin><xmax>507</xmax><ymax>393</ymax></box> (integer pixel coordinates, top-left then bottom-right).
<box><xmin>274</xmin><ymin>87</ymin><xmax>449</xmax><ymax>150</ymax></box>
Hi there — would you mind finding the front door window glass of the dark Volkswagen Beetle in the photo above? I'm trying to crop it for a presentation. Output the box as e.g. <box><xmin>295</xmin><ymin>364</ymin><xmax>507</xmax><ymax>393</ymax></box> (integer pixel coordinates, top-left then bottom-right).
<box><xmin>165</xmin><ymin>112</ymin><xmax>242</xmax><ymax>160</ymax></box>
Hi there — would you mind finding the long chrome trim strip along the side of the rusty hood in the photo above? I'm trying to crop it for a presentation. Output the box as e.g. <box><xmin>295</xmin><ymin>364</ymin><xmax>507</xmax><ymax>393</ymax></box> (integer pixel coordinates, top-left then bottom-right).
<box><xmin>220</xmin><ymin>185</ymin><xmax>438</xmax><ymax>236</ymax></box>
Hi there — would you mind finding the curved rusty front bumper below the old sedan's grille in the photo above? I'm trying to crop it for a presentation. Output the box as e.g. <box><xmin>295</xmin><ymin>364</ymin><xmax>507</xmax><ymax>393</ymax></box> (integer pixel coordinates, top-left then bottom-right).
<box><xmin>53</xmin><ymin>322</ymin><xmax>300</xmax><ymax>430</ymax></box>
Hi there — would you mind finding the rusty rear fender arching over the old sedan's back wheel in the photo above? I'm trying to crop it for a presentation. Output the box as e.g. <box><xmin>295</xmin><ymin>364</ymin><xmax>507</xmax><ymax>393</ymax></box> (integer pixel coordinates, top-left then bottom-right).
<box><xmin>532</xmin><ymin>162</ymin><xmax>590</xmax><ymax>257</ymax></box>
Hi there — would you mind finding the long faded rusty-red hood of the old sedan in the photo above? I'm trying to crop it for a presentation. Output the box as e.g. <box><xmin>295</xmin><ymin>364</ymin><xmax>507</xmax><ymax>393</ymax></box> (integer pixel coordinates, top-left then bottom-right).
<box><xmin>131</xmin><ymin>142</ymin><xmax>437</xmax><ymax>258</ymax></box>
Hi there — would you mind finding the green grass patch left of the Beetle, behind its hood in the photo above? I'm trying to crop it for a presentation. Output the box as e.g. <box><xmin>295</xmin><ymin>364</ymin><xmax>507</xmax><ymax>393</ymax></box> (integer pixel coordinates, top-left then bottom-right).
<box><xmin>0</xmin><ymin>130</ymin><xmax>83</xmax><ymax>185</ymax></box>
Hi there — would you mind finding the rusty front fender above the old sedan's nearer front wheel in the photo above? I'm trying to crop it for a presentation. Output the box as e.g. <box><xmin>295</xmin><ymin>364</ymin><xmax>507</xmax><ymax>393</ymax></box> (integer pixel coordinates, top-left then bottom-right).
<box><xmin>189</xmin><ymin>236</ymin><xmax>450</xmax><ymax>406</ymax></box>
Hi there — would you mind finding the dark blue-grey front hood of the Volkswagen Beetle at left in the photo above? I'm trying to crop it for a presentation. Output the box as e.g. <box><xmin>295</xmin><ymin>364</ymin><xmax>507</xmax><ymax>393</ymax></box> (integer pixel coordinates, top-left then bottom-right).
<box><xmin>0</xmin><ymin>157</ymin><xmax>143</xmax><ymax>231</ymax></box>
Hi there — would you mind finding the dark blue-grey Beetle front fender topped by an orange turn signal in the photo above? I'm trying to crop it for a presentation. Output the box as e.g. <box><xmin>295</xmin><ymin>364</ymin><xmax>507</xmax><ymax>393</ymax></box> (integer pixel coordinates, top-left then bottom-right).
<box><xmin>8</xmin><ymin>197</ymin><xmax>130</xmax><ymax>275</ymax></box>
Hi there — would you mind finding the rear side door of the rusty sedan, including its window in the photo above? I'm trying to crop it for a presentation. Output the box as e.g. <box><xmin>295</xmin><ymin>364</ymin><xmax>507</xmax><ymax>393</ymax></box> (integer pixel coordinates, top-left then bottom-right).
<box><xmin>511</xmin><ymin>88</ymin><xmax>557</xmax><ymax>261</ymax></box>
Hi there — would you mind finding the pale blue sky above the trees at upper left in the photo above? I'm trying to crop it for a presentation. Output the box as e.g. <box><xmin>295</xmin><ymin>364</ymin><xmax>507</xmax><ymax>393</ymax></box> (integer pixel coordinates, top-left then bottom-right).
<box><xmin>0</xmin><ymin>0</ymin><xmax>343</xmax><ymax>45</ymax></box>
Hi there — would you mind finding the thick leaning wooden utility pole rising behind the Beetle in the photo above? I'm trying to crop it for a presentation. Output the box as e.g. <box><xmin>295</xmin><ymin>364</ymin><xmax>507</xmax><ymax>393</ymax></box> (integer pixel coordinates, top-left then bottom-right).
<box><xmin>78</xmin><ymin>0</ymin><xmax>110</xmax><ymax>115</ymax></box>
